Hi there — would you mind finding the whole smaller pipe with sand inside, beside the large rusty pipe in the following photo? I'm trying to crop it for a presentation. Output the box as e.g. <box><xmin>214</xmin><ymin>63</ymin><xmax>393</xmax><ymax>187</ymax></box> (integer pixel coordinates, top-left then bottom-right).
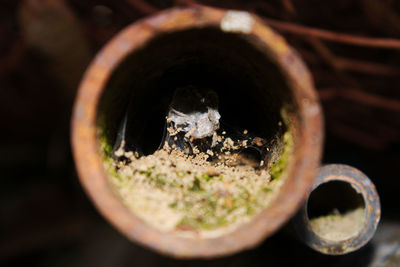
<box><xmin>294</xmin><ymin>164</ymin><xmax>381</xmax><ymax>255</ymax></box>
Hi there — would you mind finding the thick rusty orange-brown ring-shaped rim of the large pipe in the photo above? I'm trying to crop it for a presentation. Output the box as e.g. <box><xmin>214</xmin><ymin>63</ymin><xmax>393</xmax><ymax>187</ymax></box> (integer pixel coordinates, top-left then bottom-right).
<box><xmin>72</xmin><ymin>7</ymin><xmax>323</xmax><ymax>258</ymax></box>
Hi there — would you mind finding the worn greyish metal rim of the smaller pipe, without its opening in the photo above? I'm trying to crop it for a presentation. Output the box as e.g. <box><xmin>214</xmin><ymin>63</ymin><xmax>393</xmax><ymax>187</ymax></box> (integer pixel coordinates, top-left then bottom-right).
<box><xmin>294</xmin><ymin>164</ymin><xmax>381</xmax><ymax>255</ymax></box>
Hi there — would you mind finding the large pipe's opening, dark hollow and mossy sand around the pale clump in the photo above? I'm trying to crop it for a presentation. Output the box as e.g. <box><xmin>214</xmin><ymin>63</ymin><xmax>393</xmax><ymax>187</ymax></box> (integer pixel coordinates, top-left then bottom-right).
<box><xmin>97</xmin><ymin>27</ymin><xmax>300</xmax><ymax>237</ymax></box>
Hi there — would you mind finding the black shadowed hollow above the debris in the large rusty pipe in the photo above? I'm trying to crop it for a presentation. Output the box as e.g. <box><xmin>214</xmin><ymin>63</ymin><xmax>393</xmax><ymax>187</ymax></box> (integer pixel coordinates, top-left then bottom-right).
<box><xmin>98</xmin><ymin>27</ymin><xmax>297</xmax><ymax>161</ymax></box>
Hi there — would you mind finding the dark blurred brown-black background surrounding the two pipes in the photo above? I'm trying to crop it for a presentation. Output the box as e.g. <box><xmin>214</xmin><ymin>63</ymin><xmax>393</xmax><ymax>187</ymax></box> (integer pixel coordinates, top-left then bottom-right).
<box><xmin>0</xmin><ymin>0</ymin><xmax>400</xmax><ymax>267</ymax></box>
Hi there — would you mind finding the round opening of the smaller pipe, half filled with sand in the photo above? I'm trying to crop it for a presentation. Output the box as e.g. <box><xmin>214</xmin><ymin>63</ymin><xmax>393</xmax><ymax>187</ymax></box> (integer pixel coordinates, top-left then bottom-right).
<box><xmin>307</xmin><ymin>181</ymin><xmax>365</xmax><ymax>241</ymax></box>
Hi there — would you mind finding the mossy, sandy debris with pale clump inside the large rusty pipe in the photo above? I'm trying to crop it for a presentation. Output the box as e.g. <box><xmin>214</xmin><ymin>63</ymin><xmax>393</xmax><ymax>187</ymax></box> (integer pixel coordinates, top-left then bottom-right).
<box><xmin>101</xmin><ymin>86</ymin><xmax>293</xmax><ymax>238</ymax></box>
